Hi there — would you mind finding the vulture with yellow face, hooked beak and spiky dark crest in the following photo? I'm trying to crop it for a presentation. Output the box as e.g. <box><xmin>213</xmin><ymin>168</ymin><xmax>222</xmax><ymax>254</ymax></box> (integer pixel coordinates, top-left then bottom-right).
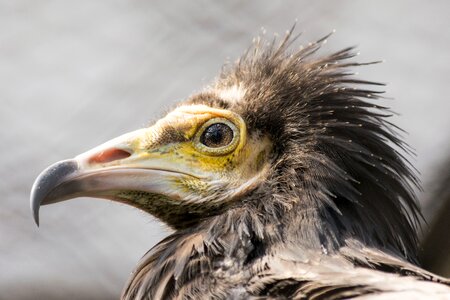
<box><xmin>30</xmin><ymin>27</ymin><xmax>450</xmax><ymax>299</ymax></box>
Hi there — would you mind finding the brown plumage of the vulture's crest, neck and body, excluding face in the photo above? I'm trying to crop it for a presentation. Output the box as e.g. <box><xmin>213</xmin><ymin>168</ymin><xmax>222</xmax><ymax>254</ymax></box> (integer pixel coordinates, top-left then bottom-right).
<box><xmin>31</xmin><ymin>27</ymin><xmax>450</xmax><ymax>299</ymax></box>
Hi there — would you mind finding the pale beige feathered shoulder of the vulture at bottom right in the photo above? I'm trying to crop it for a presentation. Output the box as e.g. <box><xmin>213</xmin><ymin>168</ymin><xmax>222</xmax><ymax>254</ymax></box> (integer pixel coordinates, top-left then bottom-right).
<box><xmin>247</xmin><ymin>241</ymin><xmax>450</xmax><ymax>299</ymax></box>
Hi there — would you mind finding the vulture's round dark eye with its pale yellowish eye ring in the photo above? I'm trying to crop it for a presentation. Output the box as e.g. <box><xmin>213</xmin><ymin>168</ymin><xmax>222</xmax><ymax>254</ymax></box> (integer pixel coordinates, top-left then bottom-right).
<box><xmin>195</xmin><ymin>118</ymin><xmax>240</xmax><ymax>155</ymax></box>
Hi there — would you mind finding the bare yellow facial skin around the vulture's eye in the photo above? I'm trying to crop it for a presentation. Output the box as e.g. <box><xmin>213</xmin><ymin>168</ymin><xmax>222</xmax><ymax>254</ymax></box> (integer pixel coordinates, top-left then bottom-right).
<box><xmin>116</xmin><ymin>105</ymin><xmax>270</xmax><ymax>203</ymax></box>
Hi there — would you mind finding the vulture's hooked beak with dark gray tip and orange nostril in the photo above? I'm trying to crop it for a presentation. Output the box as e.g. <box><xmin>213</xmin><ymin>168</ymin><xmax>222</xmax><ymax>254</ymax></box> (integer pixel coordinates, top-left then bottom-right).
<box><xmin>30</xmin><ymin>129</ymin><xmax>199</xmax><ymax>226</ymax></box>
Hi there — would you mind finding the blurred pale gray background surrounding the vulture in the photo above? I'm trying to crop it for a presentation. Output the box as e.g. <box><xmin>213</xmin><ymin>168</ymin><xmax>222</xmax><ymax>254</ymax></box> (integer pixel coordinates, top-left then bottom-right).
<box><xmin>0</xmin><ymin>0</ymin><xmax>450</xmax><ymax>299</ymax></box>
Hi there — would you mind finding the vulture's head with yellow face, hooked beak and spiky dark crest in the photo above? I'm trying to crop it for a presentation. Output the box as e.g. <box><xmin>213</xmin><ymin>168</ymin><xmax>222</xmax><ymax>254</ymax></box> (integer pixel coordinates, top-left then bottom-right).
<box><xmin>31</xmin><ymin>32</ymin><xmax>418</xmax><ymax>258</ymax></box>
